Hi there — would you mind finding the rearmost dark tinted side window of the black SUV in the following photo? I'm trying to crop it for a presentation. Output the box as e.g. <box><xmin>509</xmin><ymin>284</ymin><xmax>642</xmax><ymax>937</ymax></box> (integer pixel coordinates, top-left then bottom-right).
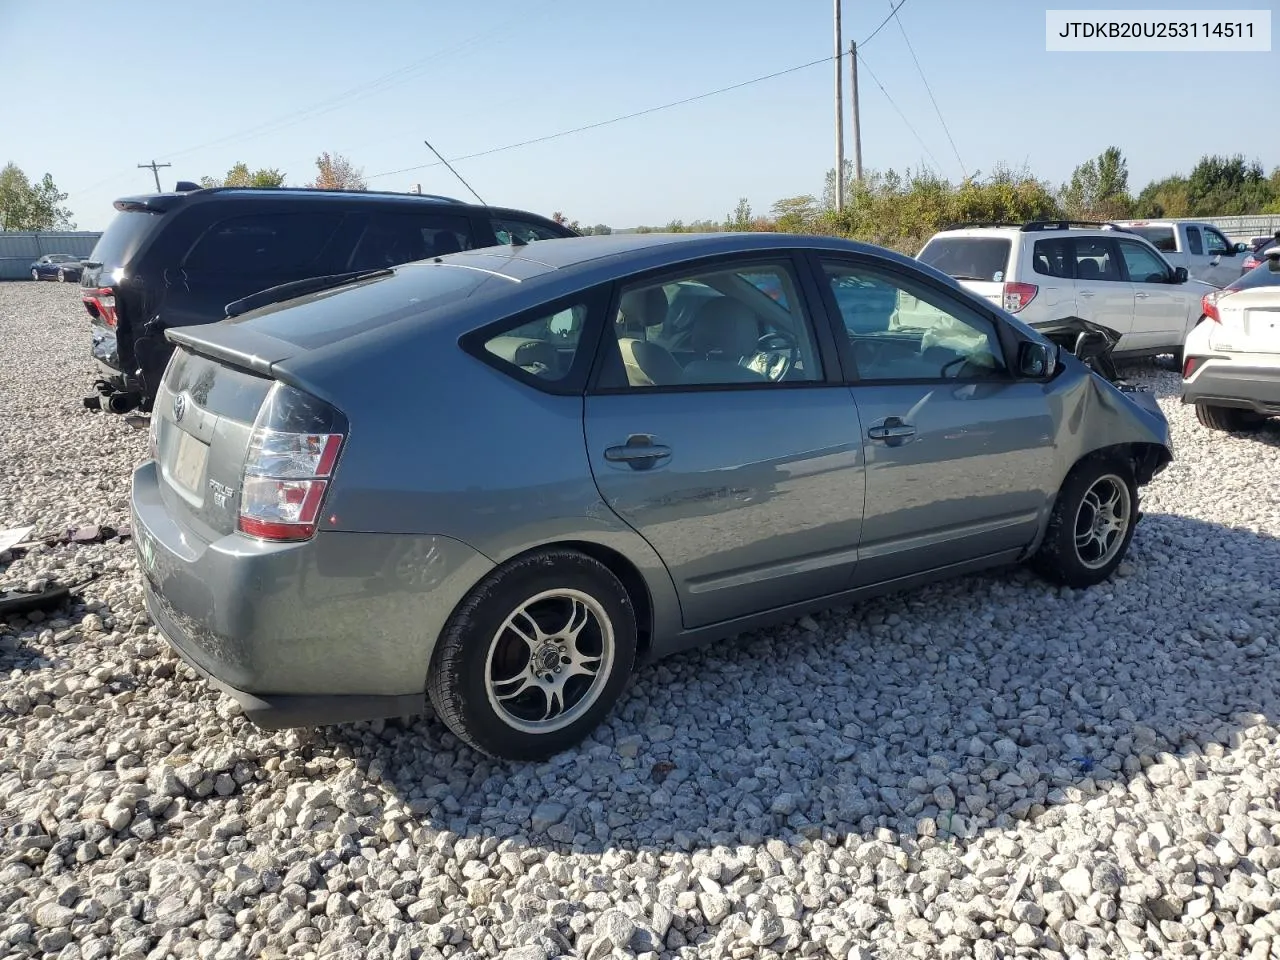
<box><xmin>183</xmin><ymin>212</ymin><xmax>342</xmax><ymax>274</ymax></box>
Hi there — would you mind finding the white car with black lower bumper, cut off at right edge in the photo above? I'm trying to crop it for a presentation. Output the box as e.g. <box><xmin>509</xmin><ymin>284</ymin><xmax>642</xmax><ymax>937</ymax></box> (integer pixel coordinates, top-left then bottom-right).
<box><xmin>1183</xmin><ymin>247</ymin><xmax>1280</xmax><ymax>430</ymax></box>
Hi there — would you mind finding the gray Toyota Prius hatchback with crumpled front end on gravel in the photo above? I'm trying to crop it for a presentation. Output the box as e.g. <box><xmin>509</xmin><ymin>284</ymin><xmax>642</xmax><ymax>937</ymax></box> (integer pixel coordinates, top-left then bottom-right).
<box><xmin>132</xmin><ymin>234</ymin><xmax>1171</xmax><ymax>759</ymax></box>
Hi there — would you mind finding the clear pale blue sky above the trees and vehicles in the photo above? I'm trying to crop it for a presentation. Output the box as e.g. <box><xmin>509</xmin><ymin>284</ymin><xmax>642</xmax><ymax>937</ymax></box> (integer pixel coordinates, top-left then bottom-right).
<box><xmin>0</xmin><ymin>0</ymin><xmax>1280</xmax><ymax>229</ymax></box>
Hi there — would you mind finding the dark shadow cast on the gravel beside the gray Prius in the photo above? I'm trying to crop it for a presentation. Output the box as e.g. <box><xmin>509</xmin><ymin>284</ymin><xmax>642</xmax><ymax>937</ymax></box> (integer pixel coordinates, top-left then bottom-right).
<box><xmin>302</xmin><ymin>515</ymin><xmax>1280</xmax><ymax>852</ymax></box>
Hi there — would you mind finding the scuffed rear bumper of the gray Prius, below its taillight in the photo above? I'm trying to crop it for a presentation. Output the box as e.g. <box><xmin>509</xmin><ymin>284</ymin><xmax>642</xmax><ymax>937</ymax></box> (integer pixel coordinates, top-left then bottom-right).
<box><xmin>131</xmin><ymin>461</ymin><xmax>493</xmax><ymax>728</ymax></box>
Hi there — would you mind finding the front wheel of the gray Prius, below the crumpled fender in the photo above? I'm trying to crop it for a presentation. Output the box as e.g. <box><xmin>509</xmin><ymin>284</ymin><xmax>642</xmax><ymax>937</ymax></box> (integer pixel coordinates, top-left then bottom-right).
<box><xmin>1032</xmin><ymin>458</ymin><xmax>1138</xmax><ymax>588</ymax></box>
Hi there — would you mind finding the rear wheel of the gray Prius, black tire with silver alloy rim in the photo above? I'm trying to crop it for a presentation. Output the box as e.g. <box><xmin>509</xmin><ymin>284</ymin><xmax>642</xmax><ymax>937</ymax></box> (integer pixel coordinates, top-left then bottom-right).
<box><xmin>428</xmin><ymin>549</ymin><xmax>636</xmax><ymax>760</ymax></box>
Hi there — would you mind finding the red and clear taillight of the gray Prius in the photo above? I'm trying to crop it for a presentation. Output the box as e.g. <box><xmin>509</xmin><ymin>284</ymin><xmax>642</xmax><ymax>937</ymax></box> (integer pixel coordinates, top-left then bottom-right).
<box><xmin>238</xmin><ymin>384</ymin><xmax>347</xmax><ymax>540</ymax></box>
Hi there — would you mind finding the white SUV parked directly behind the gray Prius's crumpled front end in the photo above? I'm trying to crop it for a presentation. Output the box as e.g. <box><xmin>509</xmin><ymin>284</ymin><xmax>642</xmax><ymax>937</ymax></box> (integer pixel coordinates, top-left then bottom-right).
<box><xmin>916</xmin><ymin>220</ymin><xmax>1216</xmax><ymax>357</ymax></box>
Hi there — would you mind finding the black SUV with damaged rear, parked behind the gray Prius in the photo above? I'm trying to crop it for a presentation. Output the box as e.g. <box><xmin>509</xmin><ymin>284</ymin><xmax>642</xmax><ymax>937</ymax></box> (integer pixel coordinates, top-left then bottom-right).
<box><xmin>81</xmin><ymin>183</ymin><xmax>577</xmax><ymax>413</ymax></box>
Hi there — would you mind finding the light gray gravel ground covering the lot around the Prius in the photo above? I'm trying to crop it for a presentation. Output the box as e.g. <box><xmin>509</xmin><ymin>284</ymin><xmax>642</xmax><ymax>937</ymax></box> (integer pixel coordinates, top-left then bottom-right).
<box><xmin>0</xmin><ymin>283</ymin><xmax>1280</xmax><ymax>960</ymax></box>
